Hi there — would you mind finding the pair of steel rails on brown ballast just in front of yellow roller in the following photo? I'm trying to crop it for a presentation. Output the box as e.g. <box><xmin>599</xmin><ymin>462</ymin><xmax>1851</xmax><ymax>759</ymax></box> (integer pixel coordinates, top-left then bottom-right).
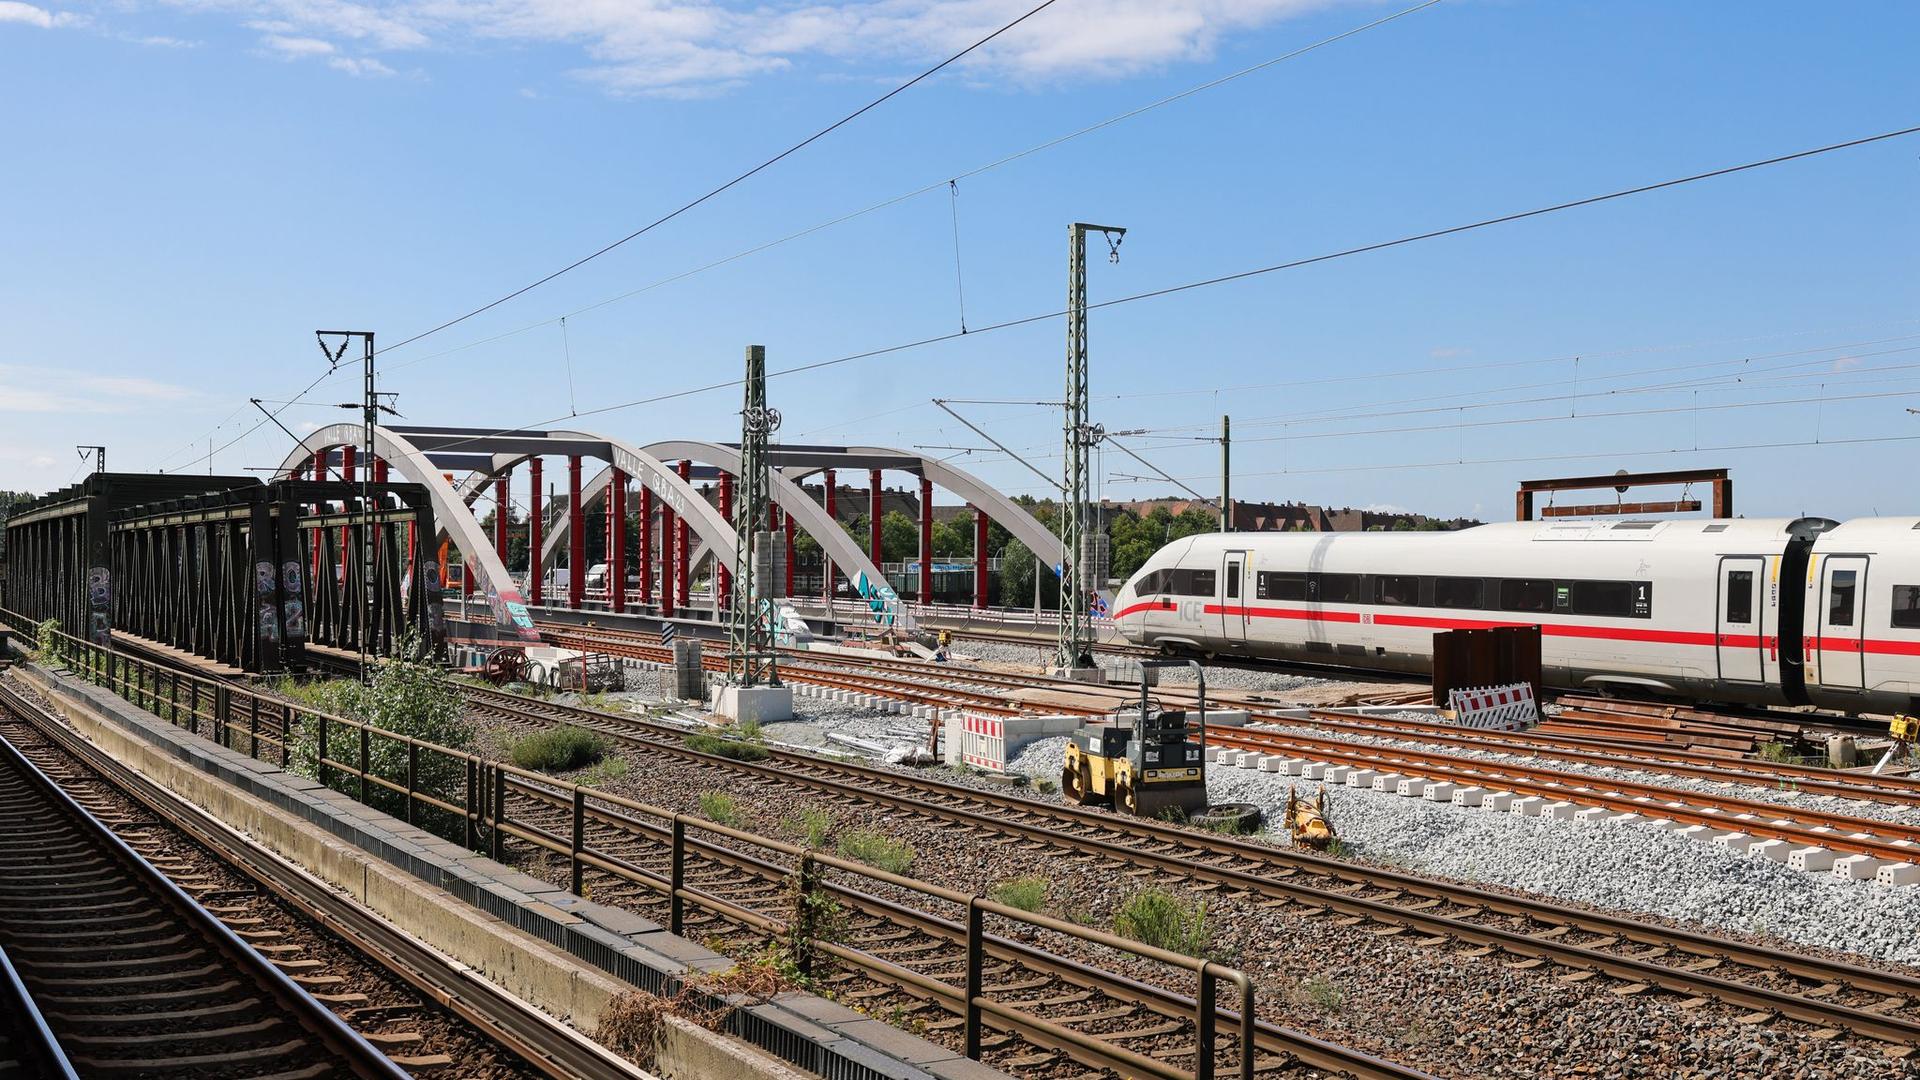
<box><xmin>460</xmin><ymin>680</ymin><xmax>1920</xmax><ymax>1043</ymax></box>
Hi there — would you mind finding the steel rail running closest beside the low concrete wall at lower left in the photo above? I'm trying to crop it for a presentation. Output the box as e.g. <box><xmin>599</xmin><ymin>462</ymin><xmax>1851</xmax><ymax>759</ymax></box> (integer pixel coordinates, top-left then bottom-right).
<box><xmin>0</xmin><ymin>686</ymin><xmax>639</xmax><ymax>1080</ymax></box>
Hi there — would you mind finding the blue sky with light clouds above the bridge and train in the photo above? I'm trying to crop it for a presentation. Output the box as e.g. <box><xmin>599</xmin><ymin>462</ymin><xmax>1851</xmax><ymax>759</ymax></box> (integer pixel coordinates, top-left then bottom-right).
<box><xmin>0</xmin><ymin>0</ymin><xmax>1920</xmax><ymax>519</ymax></box>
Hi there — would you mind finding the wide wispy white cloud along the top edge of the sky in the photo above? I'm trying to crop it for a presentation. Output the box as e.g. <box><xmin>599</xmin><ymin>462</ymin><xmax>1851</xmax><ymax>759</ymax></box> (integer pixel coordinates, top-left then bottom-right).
<box><xmin>142</xmin><ymin>0</ymin><xmax>1365</xmax><ymax>96</ymax></box>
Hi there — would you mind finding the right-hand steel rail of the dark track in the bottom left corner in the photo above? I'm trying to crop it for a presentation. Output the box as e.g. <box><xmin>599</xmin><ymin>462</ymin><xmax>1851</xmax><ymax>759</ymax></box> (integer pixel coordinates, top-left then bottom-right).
<box><xmin>0</xmin><ymin>691</ymin><xmax>409</xmax><ymax>1080</ymax></box>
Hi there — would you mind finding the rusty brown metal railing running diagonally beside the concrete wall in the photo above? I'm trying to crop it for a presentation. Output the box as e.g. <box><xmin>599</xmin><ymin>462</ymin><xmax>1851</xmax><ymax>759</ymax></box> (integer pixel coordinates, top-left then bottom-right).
<box><xmin>0</xmin><ymin>609</ymin><xmax>1256</xmax><ymax>1080</ymax></box>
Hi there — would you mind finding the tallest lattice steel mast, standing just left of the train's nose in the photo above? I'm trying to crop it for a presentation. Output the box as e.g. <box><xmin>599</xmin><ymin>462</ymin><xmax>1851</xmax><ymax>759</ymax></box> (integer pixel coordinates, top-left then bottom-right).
<box><xmin>1054</xmin><ymin>221</ymin><xmax>1127</xmax><ymax>669</ymax></box>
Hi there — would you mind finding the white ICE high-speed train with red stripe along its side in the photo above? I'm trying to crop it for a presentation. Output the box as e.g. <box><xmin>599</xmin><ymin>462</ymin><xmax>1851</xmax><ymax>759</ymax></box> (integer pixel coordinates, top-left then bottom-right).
<box><xmin>1114</xmin><ymin>517</ymin><xmax>1920</xmax><ymax>713</ymax></box>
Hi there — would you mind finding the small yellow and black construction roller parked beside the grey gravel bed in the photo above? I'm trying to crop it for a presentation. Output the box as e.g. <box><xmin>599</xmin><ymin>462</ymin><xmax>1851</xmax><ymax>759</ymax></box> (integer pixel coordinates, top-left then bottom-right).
<box><xmin>1060</xmin><ymin>661</ymin><xmax>1208</xmax><ymax>817</ymax></box>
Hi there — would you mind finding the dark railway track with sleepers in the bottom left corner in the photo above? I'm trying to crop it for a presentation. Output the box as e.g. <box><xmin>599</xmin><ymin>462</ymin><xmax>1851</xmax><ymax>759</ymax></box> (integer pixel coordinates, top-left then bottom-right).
<box><xmin>0</xmin><ymin>691</ymin><xmax>407</xmax><ymax>1080</ymax></box>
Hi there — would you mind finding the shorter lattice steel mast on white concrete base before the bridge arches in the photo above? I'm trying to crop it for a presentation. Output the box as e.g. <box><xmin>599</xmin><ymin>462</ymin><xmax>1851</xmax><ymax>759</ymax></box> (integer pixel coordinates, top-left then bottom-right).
<box><xmin>726</xmin><ymin>346</ymin><xmax>780</xmax><ymax>686</ymax></box>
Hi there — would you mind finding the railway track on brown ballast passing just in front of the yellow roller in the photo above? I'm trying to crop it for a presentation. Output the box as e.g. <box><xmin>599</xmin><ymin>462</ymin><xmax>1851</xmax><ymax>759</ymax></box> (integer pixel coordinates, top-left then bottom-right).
<box><xmin>453</xmin><ymin>690</ymin><xmax>1920</xmax><ymax>1047</ymax></box>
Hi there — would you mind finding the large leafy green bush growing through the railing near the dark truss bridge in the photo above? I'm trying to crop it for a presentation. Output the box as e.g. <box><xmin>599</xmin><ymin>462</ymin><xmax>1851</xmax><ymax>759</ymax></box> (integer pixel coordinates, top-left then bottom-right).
<box><xmin>288</xmin><ymin>642</ymin><xmax>474</xmax><ymax>836</ymax></box>
